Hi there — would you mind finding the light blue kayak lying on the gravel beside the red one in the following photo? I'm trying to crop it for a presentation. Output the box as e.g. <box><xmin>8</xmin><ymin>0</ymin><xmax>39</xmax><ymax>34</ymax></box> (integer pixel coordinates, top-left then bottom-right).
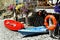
<box><xmin>18</xmin><ymin>26</ymin><xmax>48</xmax><ymax>35</ymax></box>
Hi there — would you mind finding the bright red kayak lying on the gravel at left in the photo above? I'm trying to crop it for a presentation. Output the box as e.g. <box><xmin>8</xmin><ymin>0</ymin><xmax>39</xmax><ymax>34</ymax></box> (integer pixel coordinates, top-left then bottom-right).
<box><xmin>4</xmin><ymin>20</ymin><xmax>24</xmax><ymax>31</ymax></box>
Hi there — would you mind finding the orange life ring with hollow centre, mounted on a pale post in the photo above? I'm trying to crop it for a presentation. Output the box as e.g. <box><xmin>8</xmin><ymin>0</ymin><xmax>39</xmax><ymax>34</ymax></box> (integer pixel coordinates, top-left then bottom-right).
<box><xmin>44</xmin><ymin>15</ymin><xmax>57</xmax><ymax>30</ymax></box>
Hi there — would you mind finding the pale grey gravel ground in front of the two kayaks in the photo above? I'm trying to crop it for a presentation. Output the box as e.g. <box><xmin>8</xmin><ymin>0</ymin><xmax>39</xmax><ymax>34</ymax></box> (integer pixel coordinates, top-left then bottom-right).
<box><xmin>0</xmin><ymin>20</ymin><xmax>57</xmax><ymax>40</ymax></box>
